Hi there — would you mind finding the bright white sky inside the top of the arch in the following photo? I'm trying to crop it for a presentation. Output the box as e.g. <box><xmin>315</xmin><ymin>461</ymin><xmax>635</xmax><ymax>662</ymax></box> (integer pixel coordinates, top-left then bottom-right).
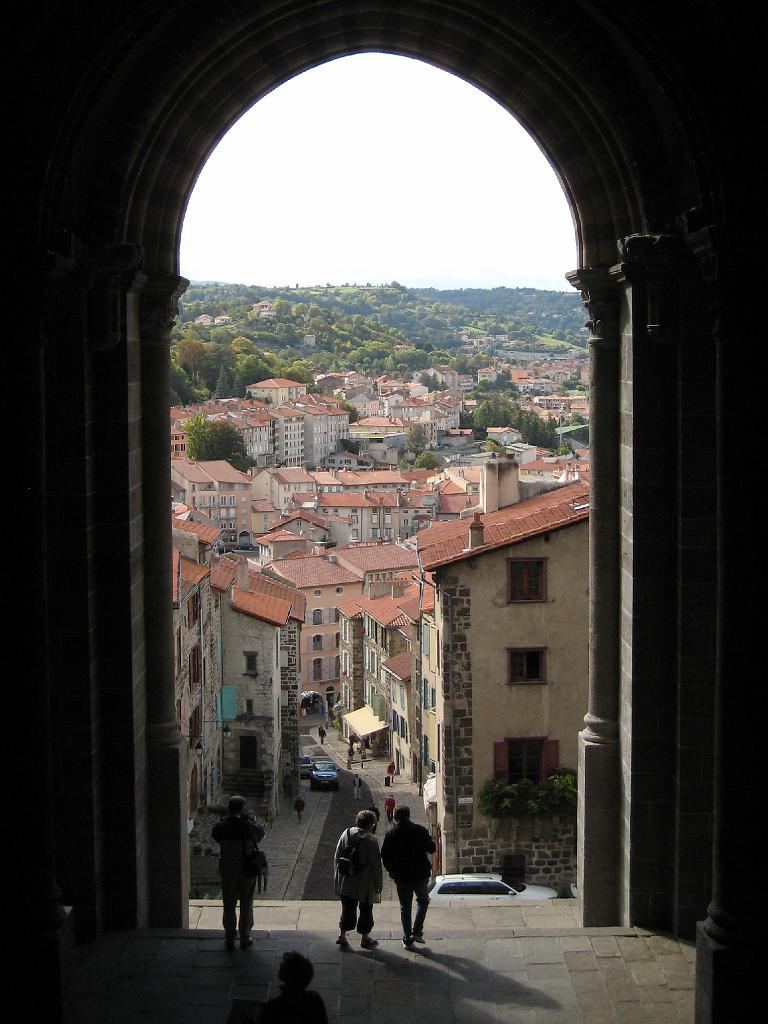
<box><xmin>181</xmin><ymin>53</ymin><xmax>577</xmax><ymax>291</ymax></box>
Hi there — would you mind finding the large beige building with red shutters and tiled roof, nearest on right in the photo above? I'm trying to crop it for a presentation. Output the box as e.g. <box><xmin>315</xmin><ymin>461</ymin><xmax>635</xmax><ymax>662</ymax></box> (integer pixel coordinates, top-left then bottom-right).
<box><xmin>419</xmin><ymin>483</ymin><xmax>589</xmax><ymax>882</ymax></box>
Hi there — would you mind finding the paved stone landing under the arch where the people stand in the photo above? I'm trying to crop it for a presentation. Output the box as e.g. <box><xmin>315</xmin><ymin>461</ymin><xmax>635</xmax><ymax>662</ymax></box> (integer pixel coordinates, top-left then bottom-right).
<box><xmin>66</xmin><ymin>900</ymin><xmax>693</xmax><ymax>1024</ymax></box>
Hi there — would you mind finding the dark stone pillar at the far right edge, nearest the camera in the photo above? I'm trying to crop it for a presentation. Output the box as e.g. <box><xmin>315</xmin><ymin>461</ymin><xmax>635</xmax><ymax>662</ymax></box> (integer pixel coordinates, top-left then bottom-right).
<box><xmin>689</xmin><ymin>227</ymin><xmax>764</xmax><ymax>1024</ymax></box>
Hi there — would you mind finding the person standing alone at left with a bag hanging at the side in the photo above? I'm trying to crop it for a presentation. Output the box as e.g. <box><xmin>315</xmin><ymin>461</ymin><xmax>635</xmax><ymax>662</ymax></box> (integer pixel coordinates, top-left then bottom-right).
<box><xmin>211</xmin><ymin>797</ymin><xmax>264</xmax><ymax>950</ymax></box>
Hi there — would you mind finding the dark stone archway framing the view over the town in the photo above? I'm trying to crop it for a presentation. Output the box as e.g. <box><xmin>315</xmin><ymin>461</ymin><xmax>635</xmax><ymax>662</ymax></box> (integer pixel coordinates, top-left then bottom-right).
<box><xmin>29</xmin><ymin>0</ymin><xmax>753</xmax><ymax>1019</ymax></box>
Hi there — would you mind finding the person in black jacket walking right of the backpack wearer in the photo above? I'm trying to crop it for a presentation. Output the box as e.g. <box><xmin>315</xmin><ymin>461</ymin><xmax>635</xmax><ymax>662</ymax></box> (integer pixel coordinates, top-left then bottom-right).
<box><xmin>381</xmin><ymin>804</ymin><xmax>435</xmax><ymax>949</ymax></box>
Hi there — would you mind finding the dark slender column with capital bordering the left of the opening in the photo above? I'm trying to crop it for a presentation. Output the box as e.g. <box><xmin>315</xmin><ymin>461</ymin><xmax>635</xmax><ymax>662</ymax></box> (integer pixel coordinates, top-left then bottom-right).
<box><xmin>138</xmin><ymin>274</ymin><xmax>189</xmax><ymax>928</ymax></box>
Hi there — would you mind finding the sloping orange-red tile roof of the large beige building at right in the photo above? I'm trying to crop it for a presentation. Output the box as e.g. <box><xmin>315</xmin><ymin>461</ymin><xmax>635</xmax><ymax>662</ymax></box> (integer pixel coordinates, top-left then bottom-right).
<box><xmin>418</xmin><ymin>482</ymin><xmax>589</xmax><ymax>569</ymax></box>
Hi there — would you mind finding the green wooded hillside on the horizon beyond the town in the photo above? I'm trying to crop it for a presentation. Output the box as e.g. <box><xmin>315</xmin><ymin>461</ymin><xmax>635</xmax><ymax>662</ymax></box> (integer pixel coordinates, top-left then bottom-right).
<box><xmin>171</xmin><ymin>282</ymin><xmax>587</xmax><ymax>401</ymax></box>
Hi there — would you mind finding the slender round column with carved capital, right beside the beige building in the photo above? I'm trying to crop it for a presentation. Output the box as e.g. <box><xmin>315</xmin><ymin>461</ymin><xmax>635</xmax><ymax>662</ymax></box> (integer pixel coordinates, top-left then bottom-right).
<box><xmin>567</xmin><ymin>268</ymin><xmax>621</xmax><ymax>927</ymax></box>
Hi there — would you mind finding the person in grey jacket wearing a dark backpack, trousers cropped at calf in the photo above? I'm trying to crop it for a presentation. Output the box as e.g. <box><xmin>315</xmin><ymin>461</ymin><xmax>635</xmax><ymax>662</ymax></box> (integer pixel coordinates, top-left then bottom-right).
<box><xmin>334</xmin><ymin>811</ymin><xmax>384</xmax><ymax>949</ymax></box>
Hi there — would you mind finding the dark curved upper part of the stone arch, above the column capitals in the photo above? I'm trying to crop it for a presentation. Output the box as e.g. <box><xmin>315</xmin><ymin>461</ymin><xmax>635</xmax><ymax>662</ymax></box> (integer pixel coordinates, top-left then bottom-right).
<box><xmin>43</xmin><ymin>0</ymin><xmax>705</xmax><ymax>273</ymax></box>
